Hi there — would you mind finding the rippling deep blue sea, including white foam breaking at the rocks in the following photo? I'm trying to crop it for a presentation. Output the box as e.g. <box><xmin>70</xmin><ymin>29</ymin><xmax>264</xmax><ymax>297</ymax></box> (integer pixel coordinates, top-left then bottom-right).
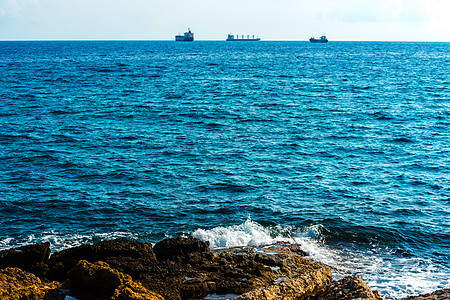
<box><xmin>0</xmin><ymin>41</ymin><xmax>450</xmax><ymax>298</ymax></box>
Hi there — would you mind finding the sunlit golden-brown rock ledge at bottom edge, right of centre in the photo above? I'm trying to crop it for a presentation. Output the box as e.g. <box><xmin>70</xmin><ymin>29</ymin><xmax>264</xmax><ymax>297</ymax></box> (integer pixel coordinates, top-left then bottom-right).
<box><xmin>234</xmin><ymin>267</ymin><xmax>332</xmax><ymax>300</ymax></box>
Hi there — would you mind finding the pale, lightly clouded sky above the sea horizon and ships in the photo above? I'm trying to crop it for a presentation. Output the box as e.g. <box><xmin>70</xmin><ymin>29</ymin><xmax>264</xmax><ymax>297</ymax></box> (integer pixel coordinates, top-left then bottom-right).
<box><xmin>0</xmin><ymin>0</ymin><xmax>450</xmax><ymax>42</ymax></box>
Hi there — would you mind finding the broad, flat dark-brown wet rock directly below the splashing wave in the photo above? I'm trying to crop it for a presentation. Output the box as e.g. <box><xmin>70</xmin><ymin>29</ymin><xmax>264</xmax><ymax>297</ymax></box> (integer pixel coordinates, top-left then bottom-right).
<box><xmin>139</xmin><ymin>241</ymin><xmax>324</xmax><ymax>299</ymax></box>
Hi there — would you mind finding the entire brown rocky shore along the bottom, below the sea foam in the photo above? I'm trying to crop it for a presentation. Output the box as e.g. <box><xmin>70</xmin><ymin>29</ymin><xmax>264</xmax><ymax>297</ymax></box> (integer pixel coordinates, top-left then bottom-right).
<box><xmin>0</xmin><ymin>238</ymin><xmax>450</xmax><ymax>300</ymax></box>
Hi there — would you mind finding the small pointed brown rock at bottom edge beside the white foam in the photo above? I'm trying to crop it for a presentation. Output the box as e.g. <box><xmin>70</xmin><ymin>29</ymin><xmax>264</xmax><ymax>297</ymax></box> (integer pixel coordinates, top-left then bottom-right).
<box><xmin>308</xmin><ymin>275</ymin><xmax>382</xmax><ymax>300</ymax></box>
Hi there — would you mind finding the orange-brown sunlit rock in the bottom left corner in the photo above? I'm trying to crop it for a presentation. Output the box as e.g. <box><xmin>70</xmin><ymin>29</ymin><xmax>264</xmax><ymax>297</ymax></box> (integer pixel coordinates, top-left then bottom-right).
<box><xmin>0</xmin><ymin>268</ymin><xmax>60</xmax><ymax>300</ymax></box>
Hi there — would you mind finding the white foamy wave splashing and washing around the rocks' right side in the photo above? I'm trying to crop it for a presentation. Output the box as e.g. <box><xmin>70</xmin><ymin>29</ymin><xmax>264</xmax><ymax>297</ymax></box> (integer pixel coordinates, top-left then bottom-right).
<box><xmin>192</xmin><ymin>218</ymin><xmax>450</xmax><ymax>299</ymax></box>
